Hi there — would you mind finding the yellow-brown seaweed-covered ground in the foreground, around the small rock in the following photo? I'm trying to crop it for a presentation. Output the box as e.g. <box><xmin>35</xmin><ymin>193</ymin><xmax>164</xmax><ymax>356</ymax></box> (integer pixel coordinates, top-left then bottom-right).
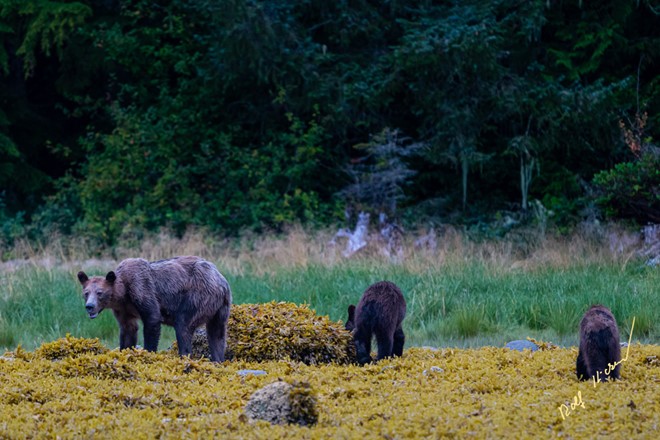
<box><xmin>0</xmin><ymin>337</ymin><xmax>660</xmax><ymax>439</ymax></box>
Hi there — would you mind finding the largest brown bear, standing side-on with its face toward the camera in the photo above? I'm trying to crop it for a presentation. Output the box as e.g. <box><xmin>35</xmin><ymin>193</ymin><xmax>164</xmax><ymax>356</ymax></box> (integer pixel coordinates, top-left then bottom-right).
<box><xmin>78</xmin><ymin>256</ymin><xmax>232</xmax><ymax>362</ymax></box>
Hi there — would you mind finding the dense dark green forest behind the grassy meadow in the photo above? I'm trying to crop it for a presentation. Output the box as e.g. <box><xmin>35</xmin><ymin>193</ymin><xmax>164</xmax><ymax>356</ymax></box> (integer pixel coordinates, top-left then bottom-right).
<box><xmin>0</xmin><ymin>0</ymin><xmax>660</xmax><ymax>243</ymax></box>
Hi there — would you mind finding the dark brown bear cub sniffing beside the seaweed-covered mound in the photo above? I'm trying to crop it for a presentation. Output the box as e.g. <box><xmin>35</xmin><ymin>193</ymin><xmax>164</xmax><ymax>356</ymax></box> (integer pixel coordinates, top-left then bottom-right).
<box><xmin>346</xmin><ymin>281</ymin><xmax>406</xmax><ymax>365</ymax></box>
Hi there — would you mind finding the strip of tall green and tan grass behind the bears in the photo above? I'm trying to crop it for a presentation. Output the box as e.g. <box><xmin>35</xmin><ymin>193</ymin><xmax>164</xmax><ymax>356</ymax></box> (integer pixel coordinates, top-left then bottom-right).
<box><xmin>0</xmin><ymin>223</ymin><xmax>660</xmax><ymax>349</ymax></box>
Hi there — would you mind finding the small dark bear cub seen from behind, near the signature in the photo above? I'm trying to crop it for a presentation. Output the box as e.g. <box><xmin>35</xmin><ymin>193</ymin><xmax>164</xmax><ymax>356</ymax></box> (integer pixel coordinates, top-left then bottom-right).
<box><xmin>576</xmin><ymin>305</ymin><xmax>621</xmax><ymax>381</ymax></box>
